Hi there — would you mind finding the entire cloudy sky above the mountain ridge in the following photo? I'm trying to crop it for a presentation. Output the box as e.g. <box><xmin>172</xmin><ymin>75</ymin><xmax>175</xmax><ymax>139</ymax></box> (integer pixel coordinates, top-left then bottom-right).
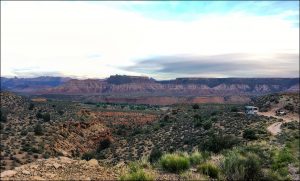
<box><xmin>1</xmin><ymin>1</ymin><xmax>299</xmax><ymax>80</ymax></box>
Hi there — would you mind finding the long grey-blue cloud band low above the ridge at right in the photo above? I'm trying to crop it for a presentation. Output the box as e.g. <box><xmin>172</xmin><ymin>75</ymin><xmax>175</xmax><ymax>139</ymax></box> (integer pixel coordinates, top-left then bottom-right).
<box><xmin>123</xmin><ymin>54</ymin><xmax>299</xmax><ymax>78</ymax></box>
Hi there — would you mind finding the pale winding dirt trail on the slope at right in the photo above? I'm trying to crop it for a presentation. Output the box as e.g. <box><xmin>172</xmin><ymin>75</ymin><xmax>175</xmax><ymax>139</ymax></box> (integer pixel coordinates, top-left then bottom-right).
<box><xmin>258</xmin><ymin>109</ymin><xmax>299</xmax><ymax>135</ymax></box>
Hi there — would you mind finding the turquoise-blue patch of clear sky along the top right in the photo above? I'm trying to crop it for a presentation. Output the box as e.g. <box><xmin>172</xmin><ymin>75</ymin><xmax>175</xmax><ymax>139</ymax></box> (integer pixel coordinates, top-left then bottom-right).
<box><xmin>104</xmin><ymin>1</ymin><xmax>299</xmax><ymax>22</ymax></box>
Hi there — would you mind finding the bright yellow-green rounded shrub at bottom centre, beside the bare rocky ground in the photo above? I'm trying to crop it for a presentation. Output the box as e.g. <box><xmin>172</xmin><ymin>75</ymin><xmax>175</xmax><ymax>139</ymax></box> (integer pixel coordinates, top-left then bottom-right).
<box><xmin>160</xmin><ymin>153</ymin><xmax>190</xmax><ymax>172</ymax></box>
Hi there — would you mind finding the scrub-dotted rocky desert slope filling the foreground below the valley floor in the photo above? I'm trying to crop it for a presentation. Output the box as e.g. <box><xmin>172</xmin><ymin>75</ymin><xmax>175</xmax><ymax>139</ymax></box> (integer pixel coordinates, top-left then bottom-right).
<box><xmin>0</xmin><ymin>92</ymin><xmax>299</xmax><ymax>180</ymax></box>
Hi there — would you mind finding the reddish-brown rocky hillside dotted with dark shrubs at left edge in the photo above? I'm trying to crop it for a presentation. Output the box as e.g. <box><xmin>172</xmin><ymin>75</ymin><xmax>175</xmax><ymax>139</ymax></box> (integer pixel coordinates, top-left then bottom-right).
<box><xmin>0</xmin><ymin>92</ymin><xmax>111</xmax><ymax>169</ymax></box>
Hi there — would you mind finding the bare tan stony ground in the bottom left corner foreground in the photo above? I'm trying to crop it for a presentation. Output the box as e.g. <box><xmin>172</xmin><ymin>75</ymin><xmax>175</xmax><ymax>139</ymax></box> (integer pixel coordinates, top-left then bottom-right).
<box><xmin>1</xmin><ymin>157</ymin><xmax>123</xmax><ymax>180</ymax></box>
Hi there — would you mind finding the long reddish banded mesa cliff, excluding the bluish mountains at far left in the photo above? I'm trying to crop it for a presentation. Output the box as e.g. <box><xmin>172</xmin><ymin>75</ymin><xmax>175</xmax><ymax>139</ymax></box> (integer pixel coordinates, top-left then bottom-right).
<box><xmin>40</xmin><ymin>76</ymin><xmax>299</xmax><ymax>97</ymax></box>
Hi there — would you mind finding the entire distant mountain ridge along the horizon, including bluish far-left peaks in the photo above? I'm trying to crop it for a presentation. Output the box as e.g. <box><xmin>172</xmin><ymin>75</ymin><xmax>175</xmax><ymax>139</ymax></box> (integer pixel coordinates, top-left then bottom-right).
<box><xmin>1</xmin><ymin>75</ymin><xmax>299</xmax><ymax>97</ymax></box>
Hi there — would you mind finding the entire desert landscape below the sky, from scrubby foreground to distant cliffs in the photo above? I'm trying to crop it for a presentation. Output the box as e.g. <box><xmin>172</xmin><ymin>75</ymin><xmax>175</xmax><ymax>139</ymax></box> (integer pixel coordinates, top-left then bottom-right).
<box><xmin>1</xmin><ymin>76</ymin><xmax>300</xmax><ymax>180</ymax></box>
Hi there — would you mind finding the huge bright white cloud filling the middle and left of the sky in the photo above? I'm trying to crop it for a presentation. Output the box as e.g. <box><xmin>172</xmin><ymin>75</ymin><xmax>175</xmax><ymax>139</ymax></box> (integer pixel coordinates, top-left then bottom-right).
<box><xmin>1</xmin><ymin>1</ymin><xmax>299</xmax><ymax>77</ymax></box>
